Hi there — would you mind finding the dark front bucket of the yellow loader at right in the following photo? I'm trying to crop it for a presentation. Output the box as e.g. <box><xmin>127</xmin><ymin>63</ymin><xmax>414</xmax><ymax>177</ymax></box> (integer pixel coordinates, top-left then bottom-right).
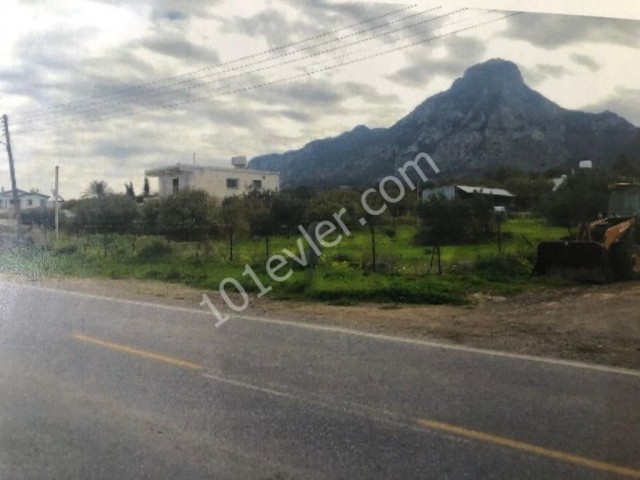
<box><xmin>533</xmin><ymin>241</ymin><xmax>612</xmax><ymax>283</ymax></box>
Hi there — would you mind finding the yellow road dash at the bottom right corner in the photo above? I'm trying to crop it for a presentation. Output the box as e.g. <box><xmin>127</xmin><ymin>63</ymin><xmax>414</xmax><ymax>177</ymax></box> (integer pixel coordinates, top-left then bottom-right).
<box><xmin>416</xmin><ymin>418</ymin><xmax>640</xmax><ymax>478</ymax></box>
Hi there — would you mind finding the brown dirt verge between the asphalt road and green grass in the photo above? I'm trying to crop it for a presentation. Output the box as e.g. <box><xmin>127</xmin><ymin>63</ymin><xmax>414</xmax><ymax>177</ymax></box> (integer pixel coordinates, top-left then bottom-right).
<box><xmin>0</xmin><ymin>276</ymin><xmax>640</xmax><ymax>369</ymax></box>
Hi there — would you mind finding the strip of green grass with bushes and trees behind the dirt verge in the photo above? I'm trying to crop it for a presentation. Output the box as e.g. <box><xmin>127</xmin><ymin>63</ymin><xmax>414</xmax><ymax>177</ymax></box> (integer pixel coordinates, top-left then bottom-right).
<box><xmin>0</xmin><ymin>160</ymin><xmax>636</xmax><ymax>304</ymax></box>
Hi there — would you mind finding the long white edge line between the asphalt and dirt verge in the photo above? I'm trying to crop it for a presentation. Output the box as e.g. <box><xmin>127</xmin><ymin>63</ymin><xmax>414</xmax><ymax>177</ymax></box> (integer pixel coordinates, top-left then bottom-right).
<box><xmin>7</xmin><ymin>282</ymin><xmax>640</xmax><ymax>378</ymax></box>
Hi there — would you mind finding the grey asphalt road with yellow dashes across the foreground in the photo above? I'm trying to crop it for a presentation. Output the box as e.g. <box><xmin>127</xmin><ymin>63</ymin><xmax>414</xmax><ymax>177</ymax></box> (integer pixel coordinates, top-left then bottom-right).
<box><xmin>0</xmin><ymin>283</ymin><xmax>640</xmax><ymax>480</ymax></box>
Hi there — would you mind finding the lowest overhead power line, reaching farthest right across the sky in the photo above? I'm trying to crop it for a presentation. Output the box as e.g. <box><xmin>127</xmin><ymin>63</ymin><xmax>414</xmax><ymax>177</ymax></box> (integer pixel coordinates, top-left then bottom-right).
<box><xmin>11</xmin><ymin>11</ymin><xmax>522</xmax><ymax>137</ymax></box>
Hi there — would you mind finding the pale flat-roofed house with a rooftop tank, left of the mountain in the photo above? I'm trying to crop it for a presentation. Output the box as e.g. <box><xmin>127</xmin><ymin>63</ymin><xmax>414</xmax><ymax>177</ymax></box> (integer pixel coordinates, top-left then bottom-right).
<box><xmin>145</xmin><ymin>157</ymin><xmax>280</xmax><ymax>199</ymax></box>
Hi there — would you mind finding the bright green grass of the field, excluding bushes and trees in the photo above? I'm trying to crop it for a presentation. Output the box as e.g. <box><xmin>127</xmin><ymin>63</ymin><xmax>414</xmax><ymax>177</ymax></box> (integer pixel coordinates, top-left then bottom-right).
<box><xmin>0</xmin><ymin>218</ymin><xmax>566</xmax><ymax>303</ymax></box>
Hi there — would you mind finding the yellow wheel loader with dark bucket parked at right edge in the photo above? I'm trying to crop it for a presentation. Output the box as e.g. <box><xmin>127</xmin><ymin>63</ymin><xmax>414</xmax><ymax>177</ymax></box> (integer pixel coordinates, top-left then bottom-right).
<box><xmin>533</xmin><ymin>183</ymin><xmax>640</xmax><ymax>283</ymax></box>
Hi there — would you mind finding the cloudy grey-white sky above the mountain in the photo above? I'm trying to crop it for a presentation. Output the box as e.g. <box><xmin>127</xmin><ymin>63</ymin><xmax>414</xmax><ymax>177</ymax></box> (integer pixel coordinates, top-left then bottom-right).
<box><xmin>0</xmin><ymin>0</ymin><xmax>640</xmax><ymax>198</ymax></box>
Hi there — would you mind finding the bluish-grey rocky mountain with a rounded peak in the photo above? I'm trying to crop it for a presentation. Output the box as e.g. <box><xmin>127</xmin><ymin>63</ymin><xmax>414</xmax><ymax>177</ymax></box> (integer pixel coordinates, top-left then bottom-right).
<box><xmin>250</xmin><ymin>59</ymin><xmax>640</xmax><ymax>186</ymax></box>
